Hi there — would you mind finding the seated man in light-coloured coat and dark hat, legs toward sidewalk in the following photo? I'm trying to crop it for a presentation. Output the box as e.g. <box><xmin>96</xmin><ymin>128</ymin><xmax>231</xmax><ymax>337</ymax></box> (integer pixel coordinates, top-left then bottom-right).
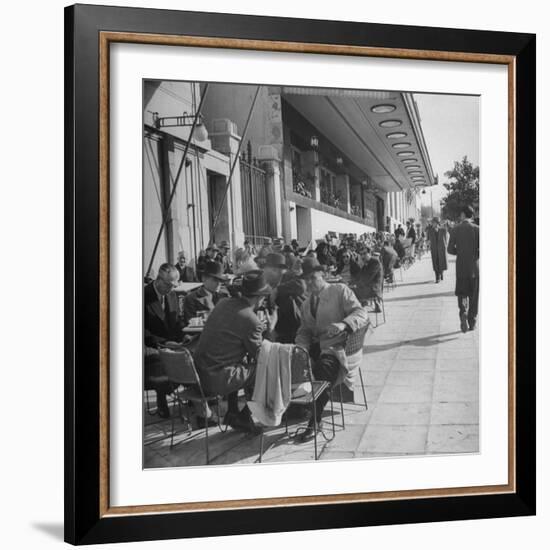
<box><xmin>296</xmin><ymin>258</ymin><xmax>368</xmax><ymax>441</ymax></box>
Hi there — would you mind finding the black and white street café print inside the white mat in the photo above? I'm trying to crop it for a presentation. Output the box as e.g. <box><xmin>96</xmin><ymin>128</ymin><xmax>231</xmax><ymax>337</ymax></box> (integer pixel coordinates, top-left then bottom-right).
<box><xmin>144</xmin><ymin>80</ymin><xmax>480</xmax><ymax>469</ymax></box>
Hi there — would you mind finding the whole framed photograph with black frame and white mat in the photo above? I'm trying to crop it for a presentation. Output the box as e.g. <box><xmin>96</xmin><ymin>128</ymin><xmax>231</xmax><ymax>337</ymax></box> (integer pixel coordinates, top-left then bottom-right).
<box><xmin>65</xmin><ymin>5</ymin><xmax>535</xmax><ymax>544</ymax></box>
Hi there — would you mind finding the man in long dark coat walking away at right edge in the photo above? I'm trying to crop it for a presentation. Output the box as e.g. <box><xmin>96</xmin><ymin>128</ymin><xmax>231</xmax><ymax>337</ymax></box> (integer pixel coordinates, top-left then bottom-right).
<box><xmin>447</xmin><ymin>206</ymin><xmax>479</xmax><ymax>332</ymax></box>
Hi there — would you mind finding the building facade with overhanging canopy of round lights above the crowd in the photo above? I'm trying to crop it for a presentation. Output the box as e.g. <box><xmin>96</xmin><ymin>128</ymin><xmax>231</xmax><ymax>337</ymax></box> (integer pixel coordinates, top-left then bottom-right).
<box><xmin>143</xmin><ymin>81</ymin><xmax>436</xmax><ymax>272</ymax></box>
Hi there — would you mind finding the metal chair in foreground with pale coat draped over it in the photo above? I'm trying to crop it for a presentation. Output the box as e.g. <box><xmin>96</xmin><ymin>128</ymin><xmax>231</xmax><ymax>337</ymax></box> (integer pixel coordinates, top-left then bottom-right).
<box><xmin>258</xmin><ymin>346</ymin><xmax>336</xmax><ymax>462</ymax></box>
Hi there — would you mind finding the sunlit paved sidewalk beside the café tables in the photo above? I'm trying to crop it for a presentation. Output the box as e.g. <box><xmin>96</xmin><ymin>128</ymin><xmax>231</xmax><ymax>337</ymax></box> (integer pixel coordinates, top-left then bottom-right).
<box><xmin>144</xmin><ymin>255</ymin><xmax>479</xmax><ymax>468</ymax></box>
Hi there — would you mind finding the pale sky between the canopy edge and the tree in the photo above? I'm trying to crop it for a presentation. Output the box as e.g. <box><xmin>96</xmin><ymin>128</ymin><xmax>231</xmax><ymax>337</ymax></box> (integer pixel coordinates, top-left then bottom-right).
<box><xmin>414</xmin><ymin>94</ymin><xmax>479</xmax><ymax>209</ymax></box>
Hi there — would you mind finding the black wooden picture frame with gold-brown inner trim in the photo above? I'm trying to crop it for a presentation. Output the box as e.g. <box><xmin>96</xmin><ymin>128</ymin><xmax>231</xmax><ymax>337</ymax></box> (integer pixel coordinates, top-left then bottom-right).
<box><xmin>65</xmin><ymin>5</ymin><xmax>536</xmax><ymax>544</ymax></box>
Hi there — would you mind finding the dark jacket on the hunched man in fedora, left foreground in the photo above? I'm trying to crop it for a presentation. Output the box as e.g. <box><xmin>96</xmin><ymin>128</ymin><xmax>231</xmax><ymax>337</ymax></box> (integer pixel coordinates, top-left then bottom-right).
<box><xmin>195</xmin><ymin>297</ymin><xmax>264</xmax><ymax>393</ymax></box>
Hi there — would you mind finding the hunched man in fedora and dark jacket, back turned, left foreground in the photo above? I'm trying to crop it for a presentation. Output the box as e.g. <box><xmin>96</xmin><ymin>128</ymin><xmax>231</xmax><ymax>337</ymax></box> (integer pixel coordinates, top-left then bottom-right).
<box><xmin>195</xmin><ymin>270</ymin><xmax>272</xmax><ymax>433</ymax></box>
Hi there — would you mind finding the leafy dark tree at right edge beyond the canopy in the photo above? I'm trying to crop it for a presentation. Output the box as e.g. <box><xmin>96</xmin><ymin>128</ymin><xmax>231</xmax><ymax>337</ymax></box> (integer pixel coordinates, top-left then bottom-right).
<box><xmin>441</xmin><ymin>157</ymin><xmax>479</xmax><ymax>221</ymax></box>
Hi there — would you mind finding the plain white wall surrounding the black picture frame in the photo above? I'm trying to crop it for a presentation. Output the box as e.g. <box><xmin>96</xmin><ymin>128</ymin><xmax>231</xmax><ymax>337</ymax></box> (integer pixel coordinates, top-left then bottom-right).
<box><xmin>0</xmin><ymin>0</ymin><xmax>550</xmax><ymax>550</ymax></box>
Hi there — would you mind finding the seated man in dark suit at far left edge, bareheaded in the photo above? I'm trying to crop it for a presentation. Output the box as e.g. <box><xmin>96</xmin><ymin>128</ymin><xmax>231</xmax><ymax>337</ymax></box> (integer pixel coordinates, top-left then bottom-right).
<box><xmin>143</xmin><ymin>264</ymin><xmax>183</xmax><ymax>418</ymax></box>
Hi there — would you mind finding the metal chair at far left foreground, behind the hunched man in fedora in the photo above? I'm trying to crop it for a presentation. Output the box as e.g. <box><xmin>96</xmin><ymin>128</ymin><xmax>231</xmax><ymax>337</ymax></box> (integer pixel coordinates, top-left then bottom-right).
<box><xmin>159</xmin><ymin>348</ymin><xmax>224</xmax><ymax>464</ymax></box>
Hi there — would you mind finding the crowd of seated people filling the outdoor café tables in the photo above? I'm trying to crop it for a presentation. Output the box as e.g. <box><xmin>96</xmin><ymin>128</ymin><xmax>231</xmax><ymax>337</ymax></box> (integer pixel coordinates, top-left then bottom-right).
<box><xmin>144</xmin><ymin>226</ymin><xmax>424</xmax><ymax>440</ymax></box>
